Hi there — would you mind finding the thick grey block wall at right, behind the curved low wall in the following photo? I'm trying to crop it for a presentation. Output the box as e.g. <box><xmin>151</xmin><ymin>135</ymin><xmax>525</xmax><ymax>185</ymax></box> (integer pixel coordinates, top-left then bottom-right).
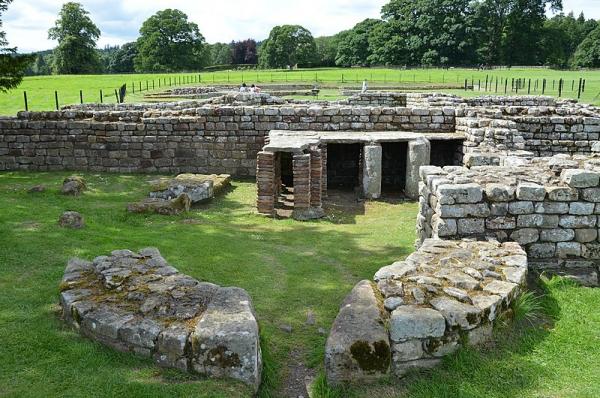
<box><xmin>417</xmin><ymin>156</ymin><xmax>600</xmax><ymax>286</ymax></box>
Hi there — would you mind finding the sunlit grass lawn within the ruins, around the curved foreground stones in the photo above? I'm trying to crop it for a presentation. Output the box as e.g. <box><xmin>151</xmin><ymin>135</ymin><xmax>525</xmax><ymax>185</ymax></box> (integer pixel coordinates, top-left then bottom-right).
<box><xmin>0</xmin><ymin>172</ymin><xmax>600</xmax><ymax>397</ymax></box>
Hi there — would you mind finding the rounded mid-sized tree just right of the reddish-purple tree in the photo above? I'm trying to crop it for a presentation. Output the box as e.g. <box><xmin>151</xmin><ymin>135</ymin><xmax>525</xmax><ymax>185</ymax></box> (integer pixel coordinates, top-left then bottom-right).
<box><xmin>259</xmin><ymin>25</ymin><xmax>317</xmax><ymax>68</ymax></box>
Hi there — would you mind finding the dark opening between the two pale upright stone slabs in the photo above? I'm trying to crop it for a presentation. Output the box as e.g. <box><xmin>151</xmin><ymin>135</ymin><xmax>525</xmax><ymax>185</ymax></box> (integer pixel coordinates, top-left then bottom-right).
<box><xmin>381</xmin><ymin>142</ymin><xmax>408</xmax><ymax>194</ymax></box>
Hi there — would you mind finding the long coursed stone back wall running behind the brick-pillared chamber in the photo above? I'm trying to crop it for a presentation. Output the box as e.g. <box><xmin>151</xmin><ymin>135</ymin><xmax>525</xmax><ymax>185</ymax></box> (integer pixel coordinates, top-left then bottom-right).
<box><xmin>0</xmin><ymin>103</ymin><xmax>455</xmax><ymax>176</ymax></box>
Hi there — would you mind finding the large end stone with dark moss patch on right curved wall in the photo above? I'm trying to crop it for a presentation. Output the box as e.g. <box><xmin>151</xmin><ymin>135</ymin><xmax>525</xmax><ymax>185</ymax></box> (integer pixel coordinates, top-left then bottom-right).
<box><xmin>325</xmin><ymin>281</ymin><xmax>391</xmax><ymax>385</ymax></box>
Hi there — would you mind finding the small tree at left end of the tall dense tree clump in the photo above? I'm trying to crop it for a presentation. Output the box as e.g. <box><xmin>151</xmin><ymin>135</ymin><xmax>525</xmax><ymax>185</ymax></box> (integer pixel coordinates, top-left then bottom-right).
<box><xmin>335</xmin><ymin>19</ymin><xmax>383</xmax><ymax>66</ymax></box>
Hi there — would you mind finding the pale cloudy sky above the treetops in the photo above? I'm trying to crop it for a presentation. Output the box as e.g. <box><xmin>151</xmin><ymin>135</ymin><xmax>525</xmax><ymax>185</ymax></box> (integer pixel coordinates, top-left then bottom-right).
<box><xmin>3</xmin><ymin>0</ymin><xmax>600</xmax><ymax>52</ymax></box>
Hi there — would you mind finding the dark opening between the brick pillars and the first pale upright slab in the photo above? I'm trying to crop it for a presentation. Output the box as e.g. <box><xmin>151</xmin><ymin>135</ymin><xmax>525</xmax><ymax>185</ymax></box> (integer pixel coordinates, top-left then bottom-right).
<box><xmin>327</xmin><ymin>144</ymin><xmax>363</xmax><ymax>190</ymax></box>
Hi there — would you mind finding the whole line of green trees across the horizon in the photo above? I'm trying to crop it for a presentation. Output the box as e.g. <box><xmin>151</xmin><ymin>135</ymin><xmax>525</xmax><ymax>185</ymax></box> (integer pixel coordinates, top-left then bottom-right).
<box><xmin>0</xmin><ymin>0</ymin><xmax>600</xmax><ymax>85</ymax></box>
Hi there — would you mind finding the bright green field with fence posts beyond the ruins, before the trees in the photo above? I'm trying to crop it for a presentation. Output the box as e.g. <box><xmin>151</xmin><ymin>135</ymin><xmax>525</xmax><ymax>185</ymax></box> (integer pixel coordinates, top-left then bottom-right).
<box><xmin>0</xmin><ymin>68</ymin><xmax>600</xmax><ymax>115</ymax></box>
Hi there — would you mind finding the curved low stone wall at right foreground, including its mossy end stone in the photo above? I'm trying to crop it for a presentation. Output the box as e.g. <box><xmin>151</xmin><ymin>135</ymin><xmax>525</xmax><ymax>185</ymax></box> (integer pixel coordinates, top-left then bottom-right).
<box><xmin>325</xmin><ymin>239</ymin><xmax>527</xmax><ymax>386</ymax></box>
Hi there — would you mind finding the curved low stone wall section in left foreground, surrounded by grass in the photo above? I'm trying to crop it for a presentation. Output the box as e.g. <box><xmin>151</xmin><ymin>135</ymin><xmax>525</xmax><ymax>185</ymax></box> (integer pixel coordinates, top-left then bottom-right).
<box><xmin>60</xmin><ymin>248</ymin><xmax>262</xmax><ymax>391</ymax></box>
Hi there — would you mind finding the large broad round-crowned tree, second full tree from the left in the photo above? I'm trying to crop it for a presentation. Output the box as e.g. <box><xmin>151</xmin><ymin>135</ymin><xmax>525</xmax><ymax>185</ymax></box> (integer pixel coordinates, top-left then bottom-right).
<box><xmin>135</xmin><ymin>9</ymin><xmax>209</xmax><ymax>72</ymax></box>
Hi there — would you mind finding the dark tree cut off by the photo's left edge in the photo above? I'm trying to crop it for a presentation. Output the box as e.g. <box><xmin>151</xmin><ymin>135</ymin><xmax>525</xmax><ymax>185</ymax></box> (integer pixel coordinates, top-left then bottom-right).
<box><xmin>0</xmin><ymin>0</ymin><xmax>34</xmax><ymax>92</ymax></box>
